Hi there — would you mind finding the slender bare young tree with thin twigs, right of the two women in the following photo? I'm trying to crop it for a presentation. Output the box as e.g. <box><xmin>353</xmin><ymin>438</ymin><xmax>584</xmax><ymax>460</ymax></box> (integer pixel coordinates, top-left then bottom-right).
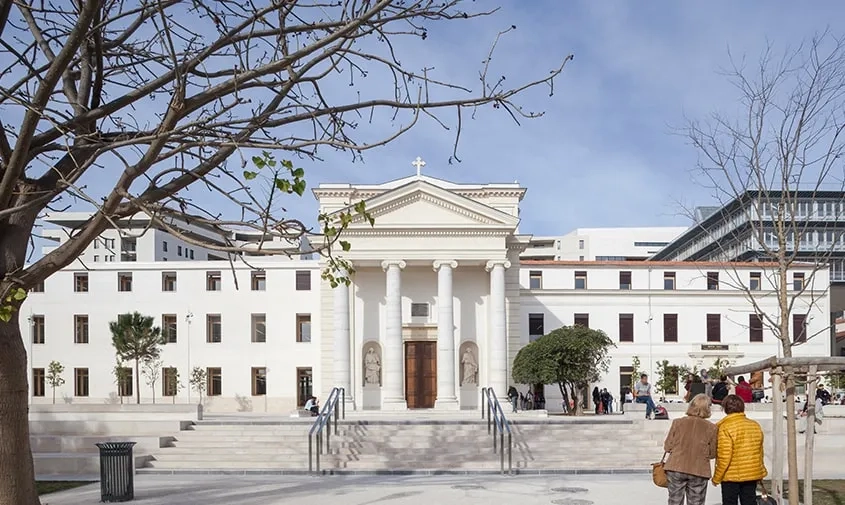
<box><xmin>680</xmin><ymin>33</ymin><xmax>845</xmax><ymax>505</ymax></box>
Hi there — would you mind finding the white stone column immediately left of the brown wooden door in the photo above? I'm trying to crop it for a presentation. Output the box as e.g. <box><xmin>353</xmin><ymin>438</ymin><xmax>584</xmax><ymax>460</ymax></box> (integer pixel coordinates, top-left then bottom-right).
<box><xmin>381</xmin><ymin>260</ymin><xmax>408</xmax><ymax>410</ymax></box>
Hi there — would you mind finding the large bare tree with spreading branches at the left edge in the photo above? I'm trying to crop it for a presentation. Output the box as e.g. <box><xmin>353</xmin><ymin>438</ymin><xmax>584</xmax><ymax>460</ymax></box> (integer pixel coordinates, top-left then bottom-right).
<box><xmin>0</xmin><ymin>0</ymin><xmax>571</xmax><ymax>505</ymax></box>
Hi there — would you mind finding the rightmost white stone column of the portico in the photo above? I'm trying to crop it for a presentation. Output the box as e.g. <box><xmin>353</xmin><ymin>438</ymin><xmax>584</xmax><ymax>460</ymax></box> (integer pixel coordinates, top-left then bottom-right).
<box><xmin>486</xmin><ymin>260</ymin><xmax>511</xmax><ymax>398</ymax></box>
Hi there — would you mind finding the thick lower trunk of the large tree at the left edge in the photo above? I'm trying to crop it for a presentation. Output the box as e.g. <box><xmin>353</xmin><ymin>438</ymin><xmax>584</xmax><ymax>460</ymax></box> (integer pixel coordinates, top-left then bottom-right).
<box><xmin>0</xmin><ymin>312</ymin><xmax>41</xmax><ymax>505</ymax></box>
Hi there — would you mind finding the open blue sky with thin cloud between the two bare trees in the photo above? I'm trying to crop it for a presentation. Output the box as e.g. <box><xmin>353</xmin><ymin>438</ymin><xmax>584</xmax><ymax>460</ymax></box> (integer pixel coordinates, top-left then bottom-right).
<box><xmin>16</xmin><ymin>0</ymin><xmax>845</xmax><ymax>240</ymax></box>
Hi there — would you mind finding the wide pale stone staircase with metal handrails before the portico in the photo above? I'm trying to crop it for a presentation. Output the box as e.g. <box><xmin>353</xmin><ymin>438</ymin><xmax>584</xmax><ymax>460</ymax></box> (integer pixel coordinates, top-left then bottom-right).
<box><xmin>138</xmin><ymin>413</ymin><xmax>668</xmax><ymax>473</ymax></box>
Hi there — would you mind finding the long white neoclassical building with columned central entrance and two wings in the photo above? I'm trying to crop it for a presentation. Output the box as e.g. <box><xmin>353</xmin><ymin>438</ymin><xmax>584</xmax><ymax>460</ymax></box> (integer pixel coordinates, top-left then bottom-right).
<box><xmin>22</xmin><ymin>173</ymin><xmax>831</xmax><ymax>412</ymax></box>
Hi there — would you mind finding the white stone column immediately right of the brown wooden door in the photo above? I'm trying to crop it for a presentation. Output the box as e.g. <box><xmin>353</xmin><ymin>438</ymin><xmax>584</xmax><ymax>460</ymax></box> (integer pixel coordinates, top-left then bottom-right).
<box><xmin>434</xmin><ymin>260</ymin><xmax>460</xmax><ymax>410</ymax></box>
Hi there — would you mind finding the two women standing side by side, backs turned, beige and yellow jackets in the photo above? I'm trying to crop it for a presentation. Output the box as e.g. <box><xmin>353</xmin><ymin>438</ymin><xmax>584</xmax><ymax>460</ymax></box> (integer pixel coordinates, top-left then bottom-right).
<box><xmin>663</xmin><ymin>393</ymin><xmax>768</xmax><ymax>505</ymax></box>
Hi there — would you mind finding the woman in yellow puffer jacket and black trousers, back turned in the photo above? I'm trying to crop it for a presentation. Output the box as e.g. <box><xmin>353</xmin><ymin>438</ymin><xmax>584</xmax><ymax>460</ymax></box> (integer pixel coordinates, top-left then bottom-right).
<box><xmin>713</xmin><ymin>395</ymin><xmax>768</xmax><ymax>505</ymax></box>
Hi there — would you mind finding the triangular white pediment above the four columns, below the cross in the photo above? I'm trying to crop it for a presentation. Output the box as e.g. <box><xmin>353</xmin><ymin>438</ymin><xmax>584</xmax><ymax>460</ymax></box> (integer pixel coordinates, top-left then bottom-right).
<box><xmin>336</xmin><ymin>180</ymin><xmax>519</xmax><ymax>229</ymax></box>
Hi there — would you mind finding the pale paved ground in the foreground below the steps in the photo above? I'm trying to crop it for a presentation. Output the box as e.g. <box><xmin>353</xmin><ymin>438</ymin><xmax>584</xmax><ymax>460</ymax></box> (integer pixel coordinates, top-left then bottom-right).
<box><xmin>33</xmin><ymin>474</ymin><xmax>756</xmax><ymax>505</ymax></box>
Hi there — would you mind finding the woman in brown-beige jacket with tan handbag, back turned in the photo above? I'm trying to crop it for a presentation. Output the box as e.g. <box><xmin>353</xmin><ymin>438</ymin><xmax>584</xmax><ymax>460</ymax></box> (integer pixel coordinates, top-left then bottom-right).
<box><xmin>663</xmin><ymin>394</ymin><xmax>718</xmax><ymax>505</ymax></box>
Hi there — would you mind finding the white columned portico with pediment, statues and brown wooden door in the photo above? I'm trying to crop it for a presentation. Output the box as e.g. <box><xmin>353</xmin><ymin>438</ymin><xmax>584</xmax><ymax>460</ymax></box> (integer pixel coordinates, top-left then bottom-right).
<box><xmin>314</xmin><ymin>162</ymin><xmax>528</xmax><ymax>410</ymax></box>
